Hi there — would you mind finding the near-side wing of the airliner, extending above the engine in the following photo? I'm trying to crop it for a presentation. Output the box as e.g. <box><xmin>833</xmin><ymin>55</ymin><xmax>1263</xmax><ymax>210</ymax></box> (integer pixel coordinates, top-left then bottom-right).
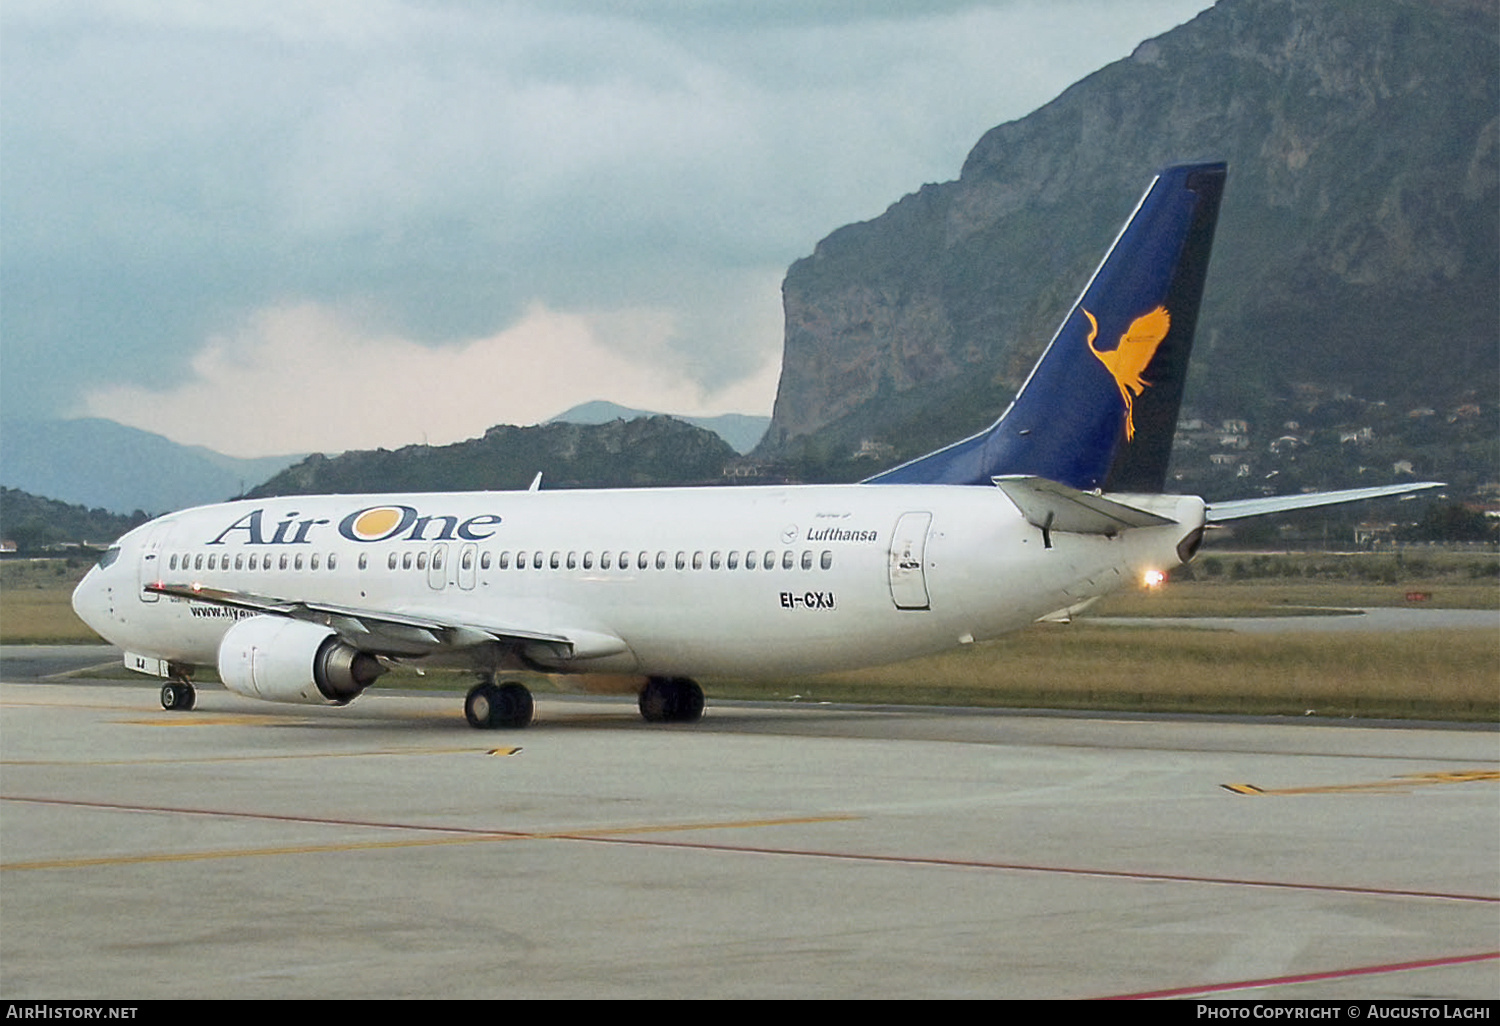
<box><xmin>146</xmin><ymin>582</ymin><xmax>627</xmax><ymax>660</ymax></box>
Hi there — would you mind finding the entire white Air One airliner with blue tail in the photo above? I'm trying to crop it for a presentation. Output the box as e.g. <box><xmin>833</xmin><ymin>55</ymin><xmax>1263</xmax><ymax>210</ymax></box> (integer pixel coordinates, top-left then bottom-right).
<box><xmin>74</xmin><ymin>164</ymin><xmax>1436</xmax><ymax>728</ymax></box>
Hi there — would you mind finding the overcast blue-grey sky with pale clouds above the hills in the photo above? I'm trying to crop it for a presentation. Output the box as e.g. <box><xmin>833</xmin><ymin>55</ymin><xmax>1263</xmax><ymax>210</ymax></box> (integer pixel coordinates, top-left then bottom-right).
<box><xmin>0</xmin><ymin>0</ymin><xmax>1209</xmax><ymax>456</ymax></box>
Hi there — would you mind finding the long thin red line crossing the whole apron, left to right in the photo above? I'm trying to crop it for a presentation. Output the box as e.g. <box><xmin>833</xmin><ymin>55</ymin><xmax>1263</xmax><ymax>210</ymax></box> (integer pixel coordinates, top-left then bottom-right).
<box><xmin>0</xmin><ymin>795</ymin><xmax>1500</xmax><ymax>905</ymax></box>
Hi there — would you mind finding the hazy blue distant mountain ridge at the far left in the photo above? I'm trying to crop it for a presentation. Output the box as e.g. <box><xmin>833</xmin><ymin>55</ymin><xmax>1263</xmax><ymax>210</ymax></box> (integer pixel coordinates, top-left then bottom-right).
<box><xmin>0</xmin><ymin>417</ymin><xmax>300</xmax><ymax>513</ymax></box>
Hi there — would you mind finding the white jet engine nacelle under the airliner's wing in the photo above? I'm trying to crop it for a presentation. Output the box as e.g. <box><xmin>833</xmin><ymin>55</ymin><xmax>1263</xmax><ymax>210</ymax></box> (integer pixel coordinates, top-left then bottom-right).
<box><xmin>219</xmin><ymin>617</ymin><xmax>386</xmax><ymax>705</ymax></box>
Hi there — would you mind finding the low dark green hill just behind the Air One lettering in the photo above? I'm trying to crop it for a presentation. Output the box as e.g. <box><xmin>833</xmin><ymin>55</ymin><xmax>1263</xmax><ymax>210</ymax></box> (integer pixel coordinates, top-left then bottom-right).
<box><xmin>249</xmin><ymin>417</ymin><xmax>735</xmax><ymax>498</ymax></box>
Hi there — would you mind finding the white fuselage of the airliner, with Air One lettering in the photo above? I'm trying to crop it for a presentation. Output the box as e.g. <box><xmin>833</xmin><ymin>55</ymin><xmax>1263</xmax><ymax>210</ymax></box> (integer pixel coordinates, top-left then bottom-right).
<box><xmin>75</xmin><ymin>485</ymin><xmax>1203</xmax><ymax>677</ymax></box>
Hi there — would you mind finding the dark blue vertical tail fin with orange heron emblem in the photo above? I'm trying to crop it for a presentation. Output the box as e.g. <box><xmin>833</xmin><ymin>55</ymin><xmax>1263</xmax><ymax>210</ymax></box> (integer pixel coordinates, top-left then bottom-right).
<box><xmin>867</xmin><ymin>164</ymin><xmax>1227</xmax><ymax>492</ymax></box>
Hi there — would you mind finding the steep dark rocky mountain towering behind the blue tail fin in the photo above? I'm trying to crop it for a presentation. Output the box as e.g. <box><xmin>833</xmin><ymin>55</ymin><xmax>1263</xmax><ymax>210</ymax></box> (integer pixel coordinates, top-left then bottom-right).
<box><xmin>762</xmin><ymin>0</ymin><xmax>1500</xmax><ymax>453</ymax></box>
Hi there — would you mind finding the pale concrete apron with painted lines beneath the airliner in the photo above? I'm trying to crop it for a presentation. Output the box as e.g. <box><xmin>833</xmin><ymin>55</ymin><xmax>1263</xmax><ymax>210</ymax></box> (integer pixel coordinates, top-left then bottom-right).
<box><xmin>0</xmin><ymin>650</ymin><xmax>1500</xmax><ymax>999</ymax></box>
